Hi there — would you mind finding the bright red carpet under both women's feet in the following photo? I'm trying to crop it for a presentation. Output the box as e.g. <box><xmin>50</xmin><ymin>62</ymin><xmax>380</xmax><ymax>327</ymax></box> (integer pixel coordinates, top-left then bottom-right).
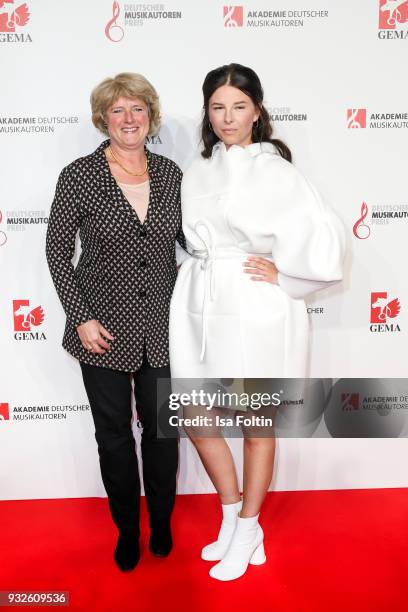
<box><xmin>0</xmin><ymin>489</ymin><xmax>408</xmax><ymax>612</ymax></box>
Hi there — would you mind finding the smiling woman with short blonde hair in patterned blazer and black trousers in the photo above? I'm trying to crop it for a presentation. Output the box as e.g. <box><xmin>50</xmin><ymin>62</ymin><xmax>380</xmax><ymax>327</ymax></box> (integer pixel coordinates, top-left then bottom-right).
<box><xmin>47</xmin><ymin>73</ymin><xmax>184</xmax><ymax>571</ymax></box>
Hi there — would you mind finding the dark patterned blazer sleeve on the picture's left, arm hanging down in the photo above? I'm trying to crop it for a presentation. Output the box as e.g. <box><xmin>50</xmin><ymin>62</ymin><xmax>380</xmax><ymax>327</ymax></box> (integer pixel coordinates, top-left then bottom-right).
<box><xmin>46</xmin><ymin>167</ymin><xmax>95</xmax><ymax>327</ymax></box>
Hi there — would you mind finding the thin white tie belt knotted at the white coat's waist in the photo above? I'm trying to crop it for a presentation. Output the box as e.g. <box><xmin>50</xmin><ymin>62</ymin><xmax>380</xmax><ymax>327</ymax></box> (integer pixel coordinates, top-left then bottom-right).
<box><xmin>192</xmin><ymin>221</ymin><xmax>266</xmax><ymax>362</ymax></box>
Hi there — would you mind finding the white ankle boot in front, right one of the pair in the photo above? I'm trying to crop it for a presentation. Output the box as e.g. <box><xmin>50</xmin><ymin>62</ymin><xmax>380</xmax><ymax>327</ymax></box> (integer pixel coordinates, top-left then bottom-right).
<box><xmin>210</xmin><ymin>514</ymin><xmax>266</xmax><ymax>580</ymax></box>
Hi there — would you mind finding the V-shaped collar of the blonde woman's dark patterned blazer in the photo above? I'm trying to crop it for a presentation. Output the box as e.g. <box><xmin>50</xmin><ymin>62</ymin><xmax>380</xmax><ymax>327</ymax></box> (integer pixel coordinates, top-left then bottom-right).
<box><xmin>88</xmin><ymin>140</ymin><xmax>165</xmax><ymax>230</ymax></box>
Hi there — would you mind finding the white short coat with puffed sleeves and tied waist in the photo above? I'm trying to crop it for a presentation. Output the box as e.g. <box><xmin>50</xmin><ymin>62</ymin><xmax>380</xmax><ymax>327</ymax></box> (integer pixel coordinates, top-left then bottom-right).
<box><xmin>170</xmin><ymin>143</ymin><xmax>344</xmax><ymax>378</ymax></box>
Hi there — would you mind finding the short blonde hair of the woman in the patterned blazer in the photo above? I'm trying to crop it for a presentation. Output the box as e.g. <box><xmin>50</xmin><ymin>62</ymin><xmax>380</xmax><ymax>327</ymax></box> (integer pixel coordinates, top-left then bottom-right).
<box><xmin>91</xmin><ymin>72</ymin><xmax>161</xmax><ymax>136</ymax></box>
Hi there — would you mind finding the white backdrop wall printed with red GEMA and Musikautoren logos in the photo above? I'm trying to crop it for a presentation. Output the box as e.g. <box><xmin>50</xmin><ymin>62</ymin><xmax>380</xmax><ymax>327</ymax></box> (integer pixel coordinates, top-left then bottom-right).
<box><xmin>0</xmin><ymin>0</ymin><xmax>408</xmax><ymax>499</ymax></box>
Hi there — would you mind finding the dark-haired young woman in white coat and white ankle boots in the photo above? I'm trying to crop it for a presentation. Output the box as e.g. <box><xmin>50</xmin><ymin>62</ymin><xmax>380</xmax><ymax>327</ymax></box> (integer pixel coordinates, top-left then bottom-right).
<box><xmin>170</xmin><ymin>64</ymin><xmax>344</xmax><ymax>580</ymax></box>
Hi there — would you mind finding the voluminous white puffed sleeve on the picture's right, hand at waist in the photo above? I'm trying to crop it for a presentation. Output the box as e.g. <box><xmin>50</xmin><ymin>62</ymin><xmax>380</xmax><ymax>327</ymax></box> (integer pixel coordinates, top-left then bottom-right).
<box><xmin>272</xmin><ymin>160</ymin><xmax>345</xmax><ymax>298</ymax></box>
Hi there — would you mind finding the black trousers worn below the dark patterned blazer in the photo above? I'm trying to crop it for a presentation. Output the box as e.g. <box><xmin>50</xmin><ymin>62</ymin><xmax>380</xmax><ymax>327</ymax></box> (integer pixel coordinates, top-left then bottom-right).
<box><xmin>81</xmin><ymin>355</ymin><xmax>178</xmax><ymax>532</ymax></box>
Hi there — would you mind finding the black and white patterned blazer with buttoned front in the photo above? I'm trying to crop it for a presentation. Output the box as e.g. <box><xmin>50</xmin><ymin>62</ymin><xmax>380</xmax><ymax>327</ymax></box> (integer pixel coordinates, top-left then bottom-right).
<box><xmin>46</xmin><ymin>141</ymin><xmax>185</xmax><ymax>372</ymax></box>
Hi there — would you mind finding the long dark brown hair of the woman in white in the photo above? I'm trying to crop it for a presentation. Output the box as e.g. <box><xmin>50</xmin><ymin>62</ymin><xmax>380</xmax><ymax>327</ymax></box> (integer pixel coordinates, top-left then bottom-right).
<box><xmin>201</xmin><ymin>64</ymin><xmax>292</xmax><ymax>162</ymax></box>
